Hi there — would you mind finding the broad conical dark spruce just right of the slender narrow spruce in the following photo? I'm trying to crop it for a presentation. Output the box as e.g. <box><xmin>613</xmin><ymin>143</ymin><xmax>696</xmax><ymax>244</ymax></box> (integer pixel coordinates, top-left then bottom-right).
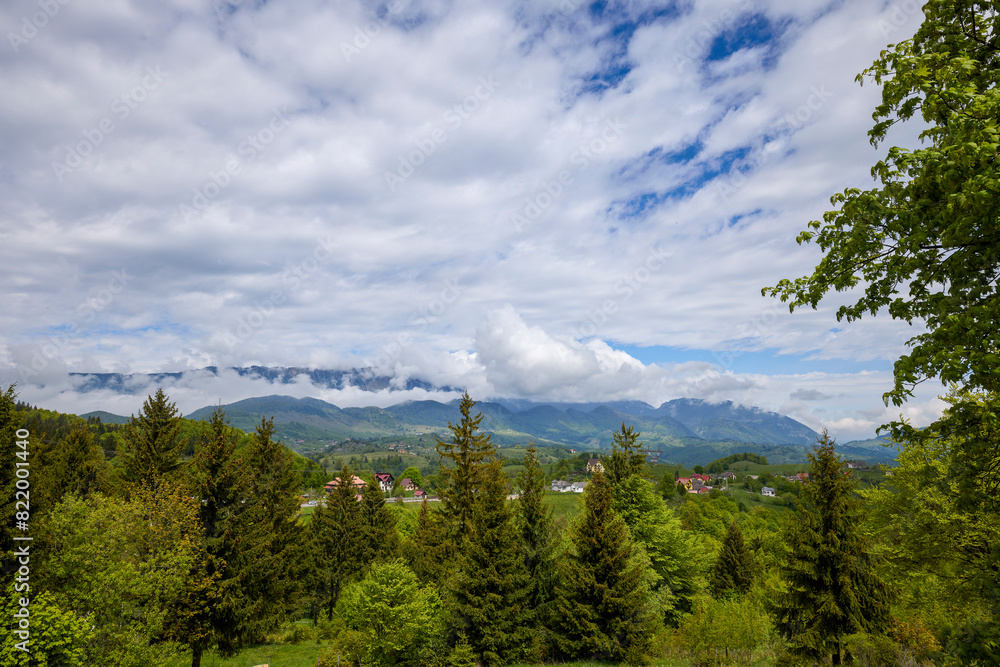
<box><xmin>555</xmin><ymin>471</ymin><xmax>655</xmax><ymax>663</ymax></box>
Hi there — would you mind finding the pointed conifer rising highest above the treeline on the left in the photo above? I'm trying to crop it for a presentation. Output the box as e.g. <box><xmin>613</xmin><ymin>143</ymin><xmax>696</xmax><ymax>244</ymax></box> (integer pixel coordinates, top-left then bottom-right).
<box><xmin>121</xmin><ymin>389</ymin><xmax>185</xmax><ymax>486</ymax></box>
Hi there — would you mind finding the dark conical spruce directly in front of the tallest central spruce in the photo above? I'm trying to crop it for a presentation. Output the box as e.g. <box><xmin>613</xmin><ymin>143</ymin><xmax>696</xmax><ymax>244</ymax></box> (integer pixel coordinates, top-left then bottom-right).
<box><xmin>453</xmin><ymin>460</ymin><xmax>533</xmax><ymax>667</ymax></box>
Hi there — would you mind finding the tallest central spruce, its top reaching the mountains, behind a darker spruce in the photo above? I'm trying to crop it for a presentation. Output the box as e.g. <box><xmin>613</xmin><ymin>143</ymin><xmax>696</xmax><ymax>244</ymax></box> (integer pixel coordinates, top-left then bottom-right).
<box><xmin>437</xmin><ymin>392</ymin><xmax>496</xmax><ymax>539</ymax></box>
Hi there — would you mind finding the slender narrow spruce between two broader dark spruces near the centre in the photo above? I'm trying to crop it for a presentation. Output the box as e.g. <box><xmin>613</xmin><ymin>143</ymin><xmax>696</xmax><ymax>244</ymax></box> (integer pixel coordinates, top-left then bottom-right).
<box><xmin>517</xmin><ymin>443</ymin><xmax>556</xmax><ymax>625</ymax></box>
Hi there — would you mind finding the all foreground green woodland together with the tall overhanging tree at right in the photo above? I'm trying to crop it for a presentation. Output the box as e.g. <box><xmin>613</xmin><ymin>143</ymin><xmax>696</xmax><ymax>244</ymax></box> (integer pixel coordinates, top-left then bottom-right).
<box><xmin>0</xmin><ymin>0</ymin><xmax>1000</xmax><ymax>667</ymax></box>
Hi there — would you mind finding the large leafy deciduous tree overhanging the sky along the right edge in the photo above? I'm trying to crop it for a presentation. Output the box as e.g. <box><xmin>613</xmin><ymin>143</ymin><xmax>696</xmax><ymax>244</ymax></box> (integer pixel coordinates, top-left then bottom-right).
<box><xmin>763</xmin><ymin>0</ymin><xmax>1000</xmax><ymax>405</ymax></box>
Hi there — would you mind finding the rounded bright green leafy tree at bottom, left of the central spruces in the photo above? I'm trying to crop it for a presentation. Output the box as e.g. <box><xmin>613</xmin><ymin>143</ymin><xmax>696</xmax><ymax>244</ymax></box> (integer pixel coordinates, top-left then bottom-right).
<box><xmin>338</xmin><ymin>560</ymin><xmax>443</xmax><ymax>667</ymax></box>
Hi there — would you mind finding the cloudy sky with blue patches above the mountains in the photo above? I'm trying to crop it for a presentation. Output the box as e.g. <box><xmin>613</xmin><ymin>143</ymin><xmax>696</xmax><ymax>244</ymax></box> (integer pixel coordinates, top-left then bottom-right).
<box><xmin>0</xmin><ymin>0</ymin><xmax>943</xmax><ymax>441</ymax></box>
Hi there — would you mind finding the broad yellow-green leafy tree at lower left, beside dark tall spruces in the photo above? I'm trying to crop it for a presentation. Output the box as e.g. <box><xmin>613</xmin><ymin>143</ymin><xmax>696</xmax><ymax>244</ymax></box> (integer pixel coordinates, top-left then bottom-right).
<box><xmin>32</xmin><ymin>482</ymin><xmax>199</xmax><ymax>667</ymax></box>
